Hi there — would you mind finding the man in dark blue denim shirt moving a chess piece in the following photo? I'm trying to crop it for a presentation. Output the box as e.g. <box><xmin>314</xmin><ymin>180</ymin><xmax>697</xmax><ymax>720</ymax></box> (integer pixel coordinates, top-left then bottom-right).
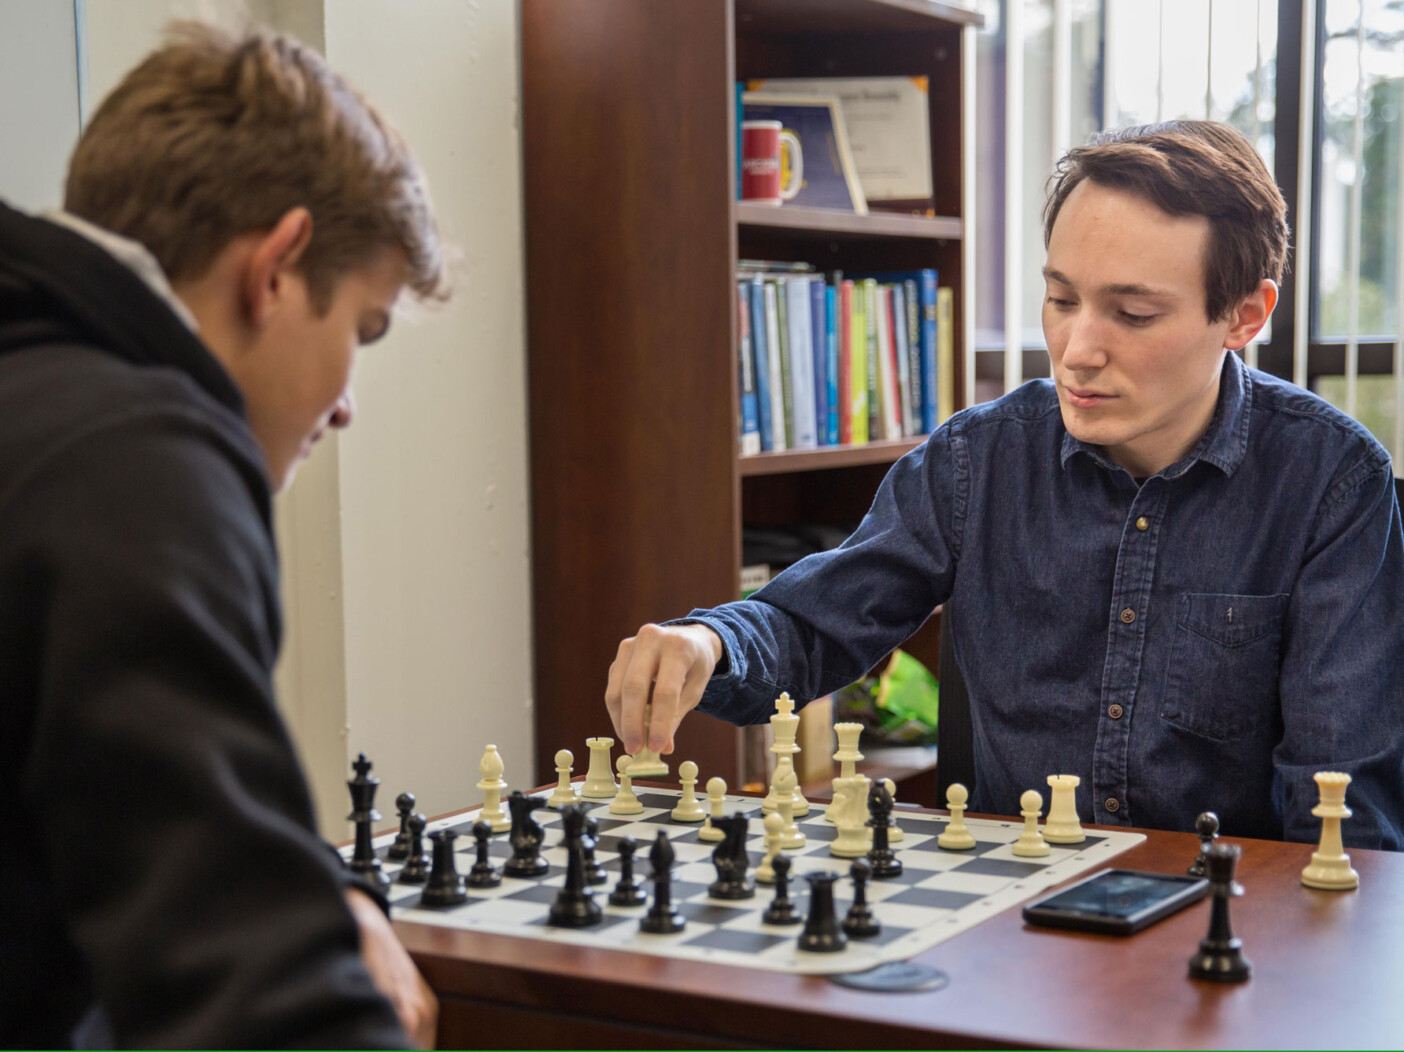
<box><xmin>605</xmin><ymin>122</ymin><xmax>1404</xmax><ymax>850</ymax></box>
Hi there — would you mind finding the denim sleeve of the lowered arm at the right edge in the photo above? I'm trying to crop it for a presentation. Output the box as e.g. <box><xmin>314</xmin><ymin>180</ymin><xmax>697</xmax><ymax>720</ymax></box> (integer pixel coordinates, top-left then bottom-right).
<box><xmin>1273</xmin><ymin>452</ymin><xmax>1404</xmax><ymax>850</ymax></box>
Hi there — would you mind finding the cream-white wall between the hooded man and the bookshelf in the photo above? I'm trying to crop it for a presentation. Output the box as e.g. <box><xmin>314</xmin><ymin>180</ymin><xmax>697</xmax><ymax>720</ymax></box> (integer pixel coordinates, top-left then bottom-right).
<box><xmin>53</xmin><ymin>0</ymin><xmax>532</xmax><ymax>839</ymax></box>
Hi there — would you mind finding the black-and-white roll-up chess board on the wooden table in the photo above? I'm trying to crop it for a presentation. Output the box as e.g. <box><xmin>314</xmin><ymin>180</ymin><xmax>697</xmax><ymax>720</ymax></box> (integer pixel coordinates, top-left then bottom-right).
<box><xmin>343</xmin><ymin>784</ymin><xmax>1146</xmax><ymax>975</ymax></box>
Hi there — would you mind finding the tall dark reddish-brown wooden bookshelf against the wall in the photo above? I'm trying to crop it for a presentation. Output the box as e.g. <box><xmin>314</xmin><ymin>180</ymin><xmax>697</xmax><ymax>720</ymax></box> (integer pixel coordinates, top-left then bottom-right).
<box><xmin>521</xmin><ymin>0</ymin><xmax>980</xmax><ymax>785</ymax></box>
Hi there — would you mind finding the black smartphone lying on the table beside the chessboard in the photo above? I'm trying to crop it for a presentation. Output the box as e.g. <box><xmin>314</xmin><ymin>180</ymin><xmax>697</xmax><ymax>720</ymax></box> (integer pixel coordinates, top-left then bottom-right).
<box><xmin>1024</xmin><ymin>869</ymin><xmax>1209</xmax><ymax>935</ymax></box>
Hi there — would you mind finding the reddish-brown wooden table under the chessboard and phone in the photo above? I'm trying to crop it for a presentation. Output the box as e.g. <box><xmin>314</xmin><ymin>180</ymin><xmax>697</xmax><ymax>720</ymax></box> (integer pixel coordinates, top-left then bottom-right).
<box><xmin>396</xmin><ymin>792</ymin><xmax>1404</xmax><ymax>1049</ymax></box>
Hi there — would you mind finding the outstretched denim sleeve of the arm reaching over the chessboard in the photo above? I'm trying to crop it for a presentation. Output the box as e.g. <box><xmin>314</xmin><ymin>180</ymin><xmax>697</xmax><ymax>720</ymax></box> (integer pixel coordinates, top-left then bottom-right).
<box><xmin>673</xmin><ymin>426</ymin><xmax>969</xmax><ymax>723</ymax></box>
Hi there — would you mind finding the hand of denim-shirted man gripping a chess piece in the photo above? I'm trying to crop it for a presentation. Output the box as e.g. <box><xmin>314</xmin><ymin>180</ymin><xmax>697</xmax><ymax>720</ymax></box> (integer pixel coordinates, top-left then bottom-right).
<box><xmin>605</xmin><ymin>625</ymin><xmax>722</xmax><ymax>756</ymax></box>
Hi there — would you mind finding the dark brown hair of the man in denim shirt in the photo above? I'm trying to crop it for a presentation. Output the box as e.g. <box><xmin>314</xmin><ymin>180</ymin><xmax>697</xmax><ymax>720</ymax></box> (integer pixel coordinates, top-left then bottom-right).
<box><xmin>1043</xmin><ymin>121</ymin><xmax>1289</xmax><ymax>322</ymax></box>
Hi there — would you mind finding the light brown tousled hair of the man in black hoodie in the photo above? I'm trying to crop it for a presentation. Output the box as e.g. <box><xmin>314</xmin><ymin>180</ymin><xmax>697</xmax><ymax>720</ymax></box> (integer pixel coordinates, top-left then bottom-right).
<box><xmin>63</xmin><ymin>22</ymin><xmax>446</xmax><ymax>309</ymax></box>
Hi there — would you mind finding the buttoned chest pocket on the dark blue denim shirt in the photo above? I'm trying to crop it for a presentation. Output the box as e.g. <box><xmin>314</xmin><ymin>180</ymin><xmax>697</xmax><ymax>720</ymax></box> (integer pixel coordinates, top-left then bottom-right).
<box><xmin>1160</xmin><ymin>593</ymin><xmax>1287</xmax><ymax>742</ymax></box>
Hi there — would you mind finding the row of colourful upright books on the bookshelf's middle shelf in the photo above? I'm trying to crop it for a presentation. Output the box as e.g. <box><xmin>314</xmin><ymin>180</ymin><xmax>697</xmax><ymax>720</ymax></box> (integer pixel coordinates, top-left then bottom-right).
<box><xmin>736</xmin><ymin>260</ymin><xmax>955</xmax><ymax>456</ymax></box>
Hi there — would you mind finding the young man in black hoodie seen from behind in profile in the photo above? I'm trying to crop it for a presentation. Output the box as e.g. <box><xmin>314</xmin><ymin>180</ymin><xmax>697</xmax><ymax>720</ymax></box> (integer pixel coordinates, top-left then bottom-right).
<box><xmin>0</xmin><ymin>25</ymin><xmax>445</xmax><ymax>1048</ymax></box>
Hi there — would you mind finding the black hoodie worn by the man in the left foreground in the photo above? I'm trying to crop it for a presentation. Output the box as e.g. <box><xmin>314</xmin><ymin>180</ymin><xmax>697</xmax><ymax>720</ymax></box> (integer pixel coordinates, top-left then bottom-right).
<box><xmin>0</xmin><ymin>205</ymin><xmax>406</xmax><ymax>1048</ymax></box>
